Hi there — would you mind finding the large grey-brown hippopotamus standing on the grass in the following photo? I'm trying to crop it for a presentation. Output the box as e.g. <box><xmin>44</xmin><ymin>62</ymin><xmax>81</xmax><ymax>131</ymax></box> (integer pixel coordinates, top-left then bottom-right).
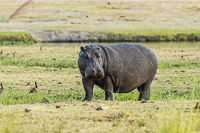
<box><xmin>78</xmin><ymin>43</ymin><xmax>158</xmax><ymax>101</ymax></box>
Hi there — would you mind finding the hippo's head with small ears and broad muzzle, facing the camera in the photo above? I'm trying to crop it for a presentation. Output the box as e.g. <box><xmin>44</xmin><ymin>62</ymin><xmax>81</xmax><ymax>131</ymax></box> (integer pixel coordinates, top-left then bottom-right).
<box><xmin>78</xmin><ymin>45</ymin><xmax>105</xmax><ymax>78</ymax></box>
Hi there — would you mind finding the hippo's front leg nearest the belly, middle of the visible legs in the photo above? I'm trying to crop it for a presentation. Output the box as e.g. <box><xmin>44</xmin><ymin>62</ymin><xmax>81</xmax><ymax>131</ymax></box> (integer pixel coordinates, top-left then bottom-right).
<box><xmin>104</xmin><ymin>77</ymin><xmax>114</xmax><ymax>101</ymax></box>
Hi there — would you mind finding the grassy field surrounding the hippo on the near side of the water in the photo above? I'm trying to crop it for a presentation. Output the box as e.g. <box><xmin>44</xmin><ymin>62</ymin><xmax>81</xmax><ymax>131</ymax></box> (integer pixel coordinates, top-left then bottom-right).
<box><xmin>0</xmin><ymin>43</ymin><xmax>200</xmax><ymax>133</ymax></box>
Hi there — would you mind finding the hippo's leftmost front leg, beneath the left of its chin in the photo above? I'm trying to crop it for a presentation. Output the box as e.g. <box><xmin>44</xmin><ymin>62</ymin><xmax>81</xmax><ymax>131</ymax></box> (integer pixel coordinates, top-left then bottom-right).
<box><xmin>82</xmin><ymin>77</ymin><xmax>94</xmax><ymax>102</ymax></box>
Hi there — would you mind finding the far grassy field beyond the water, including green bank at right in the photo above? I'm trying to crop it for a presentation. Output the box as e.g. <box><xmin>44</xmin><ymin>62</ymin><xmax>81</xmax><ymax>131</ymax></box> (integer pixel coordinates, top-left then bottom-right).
<box><xmin>0</xmin><ymin>0</ymin><xmax>200</xmax><ymax>42</ymax></box>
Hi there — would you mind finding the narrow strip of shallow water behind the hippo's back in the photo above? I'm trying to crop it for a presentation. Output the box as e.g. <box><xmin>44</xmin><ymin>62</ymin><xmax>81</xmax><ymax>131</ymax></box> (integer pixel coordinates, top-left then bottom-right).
<box><xmin>37</xmin><ymin>42</ymin><xmax>200</xmax><ymax>48</ymax></box>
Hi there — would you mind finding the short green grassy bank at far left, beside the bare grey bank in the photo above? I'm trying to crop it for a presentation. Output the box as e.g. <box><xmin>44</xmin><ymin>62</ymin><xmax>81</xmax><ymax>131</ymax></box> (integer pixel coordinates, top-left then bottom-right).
<box><xmin>0</xmin><ymin>32</ymin><xmax>36</xmax><ymax>44</ymax></box>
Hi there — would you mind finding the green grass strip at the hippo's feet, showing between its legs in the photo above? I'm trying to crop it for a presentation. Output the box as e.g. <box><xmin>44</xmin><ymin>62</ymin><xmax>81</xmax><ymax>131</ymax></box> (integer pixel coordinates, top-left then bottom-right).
<box><xmin>0</xmin><ymin>81</ymin><xmax>200</xmax><ymax>105</ymax></box>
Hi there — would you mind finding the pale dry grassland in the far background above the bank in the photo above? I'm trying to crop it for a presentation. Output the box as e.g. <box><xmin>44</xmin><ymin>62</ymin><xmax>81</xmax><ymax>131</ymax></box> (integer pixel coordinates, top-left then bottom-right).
<box><xmin>0</xmin><ymin>0</ymin><xmax>200</xmax><ymax>31</ymax></box>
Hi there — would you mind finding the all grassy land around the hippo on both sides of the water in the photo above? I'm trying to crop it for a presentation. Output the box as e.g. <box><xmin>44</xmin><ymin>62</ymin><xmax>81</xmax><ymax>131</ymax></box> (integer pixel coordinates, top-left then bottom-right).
<box><xmin>0</xmin><ymin>0</ymin><xmax>200</xmax><ymax>133</ymax></box>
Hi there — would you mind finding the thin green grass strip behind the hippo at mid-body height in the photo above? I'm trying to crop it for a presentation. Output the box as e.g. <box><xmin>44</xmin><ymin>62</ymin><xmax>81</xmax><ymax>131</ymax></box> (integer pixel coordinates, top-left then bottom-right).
<box><xmin>0</xmin><ymin>56</ymin><xmax>200</xmax><ymax>69</ymax></box>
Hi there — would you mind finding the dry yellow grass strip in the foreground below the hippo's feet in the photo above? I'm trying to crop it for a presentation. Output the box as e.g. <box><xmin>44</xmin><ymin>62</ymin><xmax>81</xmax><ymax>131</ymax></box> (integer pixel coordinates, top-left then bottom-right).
<box><xmin>0</xmin><ymin>100</ymin><xmax>199</xmax><ymax>133</ymax></box>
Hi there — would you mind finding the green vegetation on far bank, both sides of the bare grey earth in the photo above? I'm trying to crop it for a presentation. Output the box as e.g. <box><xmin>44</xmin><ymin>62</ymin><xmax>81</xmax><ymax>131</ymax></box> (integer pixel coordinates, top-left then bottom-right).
<box><xmin>0</xmin><ymin>28</ymin><xmax>200</xmax><ymax>44</ymax></box>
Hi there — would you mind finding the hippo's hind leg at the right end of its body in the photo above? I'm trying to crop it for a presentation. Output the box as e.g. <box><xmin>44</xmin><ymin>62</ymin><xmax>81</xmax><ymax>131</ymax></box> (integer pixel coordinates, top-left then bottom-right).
<box><xmin>137</xmin><ymin>78</ymin><xmax>153</xmax><ymax>101</ymax></box>
